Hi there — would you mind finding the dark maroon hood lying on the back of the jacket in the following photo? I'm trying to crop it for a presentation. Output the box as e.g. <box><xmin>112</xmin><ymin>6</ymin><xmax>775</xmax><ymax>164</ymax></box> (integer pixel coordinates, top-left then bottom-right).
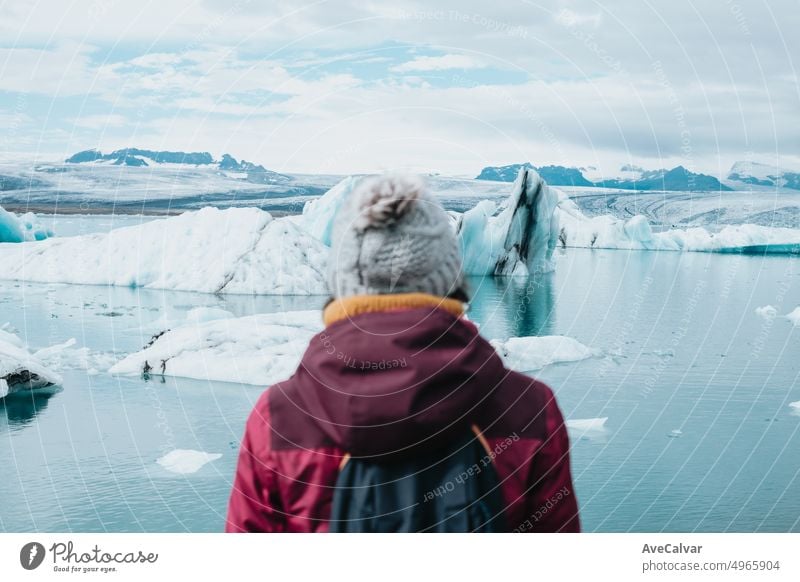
<box><xmin>294</xmin><ymin>307</ymin><xmax>507</xmax><ymax>464</ymax></box>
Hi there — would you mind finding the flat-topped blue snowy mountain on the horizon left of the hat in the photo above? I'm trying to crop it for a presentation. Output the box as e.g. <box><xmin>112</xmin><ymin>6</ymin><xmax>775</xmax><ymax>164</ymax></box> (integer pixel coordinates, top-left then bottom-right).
<box><xmin>64</xmin><ymin>148</ymin><xmax>291</xmax><ymax>184</ymax></box>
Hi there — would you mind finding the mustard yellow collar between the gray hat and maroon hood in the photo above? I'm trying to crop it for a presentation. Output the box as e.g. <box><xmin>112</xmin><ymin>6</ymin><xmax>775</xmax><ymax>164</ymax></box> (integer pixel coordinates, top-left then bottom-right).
<box><xmin>322</xmin><ymin>293</ymin><xmax>464</xmax><ymax>326</ymax></box>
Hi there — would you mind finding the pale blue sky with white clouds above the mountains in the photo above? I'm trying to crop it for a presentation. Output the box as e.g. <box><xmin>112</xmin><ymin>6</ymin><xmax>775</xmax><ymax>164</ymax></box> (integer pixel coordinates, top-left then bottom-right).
<box><xmin>0</xmin><ymin>0</ymin><xmax>800</xmax><ymax>176</ymax></box>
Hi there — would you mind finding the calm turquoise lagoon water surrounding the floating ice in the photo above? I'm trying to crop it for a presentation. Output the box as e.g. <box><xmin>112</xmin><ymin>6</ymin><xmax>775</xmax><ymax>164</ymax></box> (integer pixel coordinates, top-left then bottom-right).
<box><xmin>0</xmin><ymin>249</ymin><xmax>800</xmax><ymax>531</ymax></box>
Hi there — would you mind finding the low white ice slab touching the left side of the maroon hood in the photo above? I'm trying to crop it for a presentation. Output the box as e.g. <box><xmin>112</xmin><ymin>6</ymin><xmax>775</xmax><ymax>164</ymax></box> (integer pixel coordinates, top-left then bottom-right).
<box><xmin>109</xmin><ymin>311</ymin><xmax>322</xmax><ymax>386</ymax></box>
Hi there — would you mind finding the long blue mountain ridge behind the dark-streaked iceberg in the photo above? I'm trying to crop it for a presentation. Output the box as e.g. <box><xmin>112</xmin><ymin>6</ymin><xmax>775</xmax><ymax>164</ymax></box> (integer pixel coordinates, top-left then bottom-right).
<box><xmin>476</xmin><ymin>162</ymin><xmax>733</xmax><ymax>192</ymax></box>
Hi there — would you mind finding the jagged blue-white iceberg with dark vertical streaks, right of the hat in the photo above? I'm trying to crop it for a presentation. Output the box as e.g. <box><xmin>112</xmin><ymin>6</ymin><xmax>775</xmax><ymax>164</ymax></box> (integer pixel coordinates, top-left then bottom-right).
<box><xmin>456</xmin><ymin>168</ymin><xmax>559</xmax><ymax>276</ymax></box>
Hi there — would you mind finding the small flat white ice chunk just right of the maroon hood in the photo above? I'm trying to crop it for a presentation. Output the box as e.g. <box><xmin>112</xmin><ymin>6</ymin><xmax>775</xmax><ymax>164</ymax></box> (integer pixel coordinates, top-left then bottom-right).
<box><xmin>491</xmin><ymin>335</ymin><xmax>600</xmax><ymax>372</ymax></box>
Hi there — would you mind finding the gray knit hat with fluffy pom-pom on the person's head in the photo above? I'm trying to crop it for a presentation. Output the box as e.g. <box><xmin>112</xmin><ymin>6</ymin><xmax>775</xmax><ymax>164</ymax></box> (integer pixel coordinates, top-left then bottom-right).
<box><xmin>328</xmin><ymin>175</ymin><xmax>463</xmax><ymax>298</ymax></box>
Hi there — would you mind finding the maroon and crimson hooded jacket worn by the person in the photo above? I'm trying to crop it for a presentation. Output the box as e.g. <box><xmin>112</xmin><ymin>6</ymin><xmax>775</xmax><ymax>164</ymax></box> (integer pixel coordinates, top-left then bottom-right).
<box><xmin>225</xmin><ymin>308</ymin><xmax>580</xmax><ymax>532</ymax></box>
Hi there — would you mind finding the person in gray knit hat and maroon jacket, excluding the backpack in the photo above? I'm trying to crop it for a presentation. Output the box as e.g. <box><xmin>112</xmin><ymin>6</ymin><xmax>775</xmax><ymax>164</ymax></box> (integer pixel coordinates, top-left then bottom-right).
<box><xmin>226</xmin><ymin>175</ymin><xmax>580</xmax><ymax>532</ymax></box>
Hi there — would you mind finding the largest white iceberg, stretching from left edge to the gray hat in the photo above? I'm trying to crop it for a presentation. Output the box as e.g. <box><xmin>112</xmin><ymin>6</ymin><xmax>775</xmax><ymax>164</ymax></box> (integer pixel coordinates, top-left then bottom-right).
<box><xmin>0</xmin><ymin>207</ymin><xmax>328</xmax><ymax>295</ymax></box>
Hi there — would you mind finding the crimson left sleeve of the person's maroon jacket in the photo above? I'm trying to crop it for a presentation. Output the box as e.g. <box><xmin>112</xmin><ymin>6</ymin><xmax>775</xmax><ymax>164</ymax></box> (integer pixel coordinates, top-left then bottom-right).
<box><xmin>225</xmin><ymin>395</ymin><xmax>286</xmax><ymax>532</ymax></box>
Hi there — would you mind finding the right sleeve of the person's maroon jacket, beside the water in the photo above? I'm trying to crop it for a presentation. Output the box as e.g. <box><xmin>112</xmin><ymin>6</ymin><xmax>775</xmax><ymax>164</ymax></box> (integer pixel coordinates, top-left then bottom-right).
<box><xmin>517</xmin><ymin>388</ymin><xmax>581</xmax><ymax>533</ymax></box>
